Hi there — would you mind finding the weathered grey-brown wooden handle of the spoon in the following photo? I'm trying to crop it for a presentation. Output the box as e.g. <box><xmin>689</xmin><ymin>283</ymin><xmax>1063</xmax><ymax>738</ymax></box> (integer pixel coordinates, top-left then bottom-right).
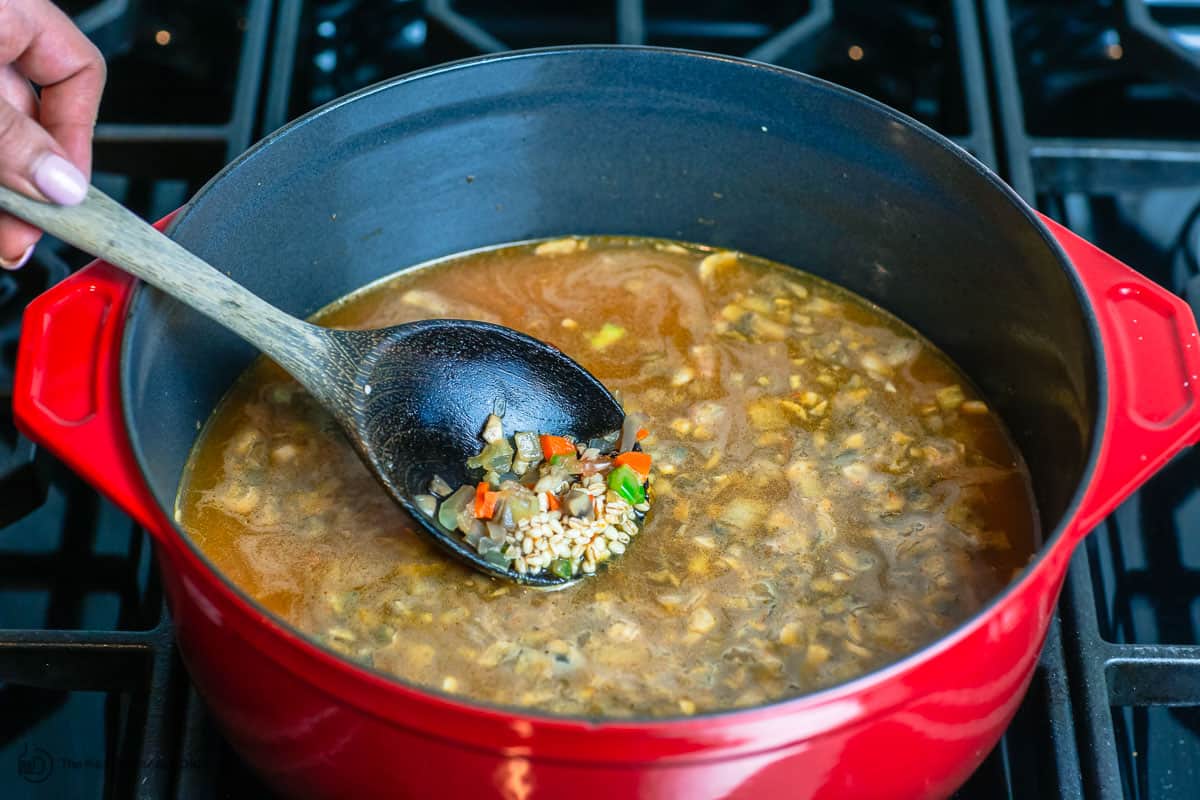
<box><xmin>0</xmin><ymin>186</ymin><xmax>331</xmax><ymax>398</ymax></box>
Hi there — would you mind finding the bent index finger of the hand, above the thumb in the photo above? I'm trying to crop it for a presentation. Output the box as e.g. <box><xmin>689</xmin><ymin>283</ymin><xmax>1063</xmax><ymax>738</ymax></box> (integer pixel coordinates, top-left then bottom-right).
<box><xmin>0</xmin><ymin>0</ymin><xmax>106</xmax><ymax>175</ymax></box>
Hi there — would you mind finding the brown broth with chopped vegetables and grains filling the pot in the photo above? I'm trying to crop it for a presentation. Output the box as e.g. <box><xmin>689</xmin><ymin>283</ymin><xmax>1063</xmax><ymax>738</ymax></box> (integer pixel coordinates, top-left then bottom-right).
<box><xmin>178</xmin><ymin>237</ymin><xmax>1037</xmax><ymax>717</ymax></box>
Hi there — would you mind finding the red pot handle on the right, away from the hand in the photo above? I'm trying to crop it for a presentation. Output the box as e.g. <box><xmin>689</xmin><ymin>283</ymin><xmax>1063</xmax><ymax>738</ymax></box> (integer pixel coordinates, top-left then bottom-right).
<box><xmin>1042</xmin><ymin>217</ymin><xmax>1200</xmax><ymax>535</ymax></box>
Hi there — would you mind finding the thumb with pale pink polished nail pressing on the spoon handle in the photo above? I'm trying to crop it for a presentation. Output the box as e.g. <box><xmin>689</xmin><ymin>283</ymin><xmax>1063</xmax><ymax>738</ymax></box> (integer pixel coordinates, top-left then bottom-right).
<box><xmin>0</xmin><ymin>93</ymin><xmax>88</xmax><ymax>205</ymax></box>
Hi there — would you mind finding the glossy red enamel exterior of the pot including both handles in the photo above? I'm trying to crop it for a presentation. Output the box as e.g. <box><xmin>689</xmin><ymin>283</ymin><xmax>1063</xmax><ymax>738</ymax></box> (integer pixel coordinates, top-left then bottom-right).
<box><xmin>13</xmin><ymin>214</ymin><xmax>1200</xmax><ymax>800</ymax></box>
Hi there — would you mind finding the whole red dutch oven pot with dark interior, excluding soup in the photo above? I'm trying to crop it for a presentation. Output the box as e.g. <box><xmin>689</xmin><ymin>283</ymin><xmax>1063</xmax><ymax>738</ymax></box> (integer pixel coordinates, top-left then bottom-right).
<box><xmin>13</xmin><ymin>47</ymin><xmax>1200</xmax><ymax>800</ymax></box>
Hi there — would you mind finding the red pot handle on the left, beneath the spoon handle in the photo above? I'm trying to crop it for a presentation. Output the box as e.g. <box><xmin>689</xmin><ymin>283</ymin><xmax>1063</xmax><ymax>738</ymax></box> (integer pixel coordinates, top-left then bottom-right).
<box><xmin>12</xmin><ymin>217</ymin><xmax>170</xmax><ymax>534</ymax></box>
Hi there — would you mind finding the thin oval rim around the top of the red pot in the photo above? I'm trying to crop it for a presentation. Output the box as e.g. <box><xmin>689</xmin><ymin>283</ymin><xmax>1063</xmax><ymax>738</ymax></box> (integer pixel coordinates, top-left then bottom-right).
<box><xmin>119</xmin><ymin>44</ymin><xmax>1110</xmax><ymax>750</ymax></box>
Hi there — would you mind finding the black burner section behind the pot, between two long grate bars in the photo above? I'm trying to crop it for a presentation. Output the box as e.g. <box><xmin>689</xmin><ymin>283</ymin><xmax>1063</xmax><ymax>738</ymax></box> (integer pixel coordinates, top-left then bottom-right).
<box><xmin>280</xmin><ymin>0</ymin><xmax>982</xmax><ymax>141</ymax></box>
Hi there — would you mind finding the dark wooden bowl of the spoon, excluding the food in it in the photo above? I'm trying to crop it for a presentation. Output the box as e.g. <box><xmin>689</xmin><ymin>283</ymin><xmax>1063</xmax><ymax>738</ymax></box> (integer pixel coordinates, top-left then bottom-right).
<box><xmin>345</xmin><ymin>319</ymin><xmax>624</xmax><ymax>589</ymax></box>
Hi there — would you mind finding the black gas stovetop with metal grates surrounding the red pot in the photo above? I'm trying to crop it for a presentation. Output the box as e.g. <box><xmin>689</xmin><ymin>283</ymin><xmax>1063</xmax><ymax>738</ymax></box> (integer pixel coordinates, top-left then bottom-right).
<box><xmin>0</xmin><ymin>0</ymin><xmax>1200</xmax><ymax>800</ymax></box>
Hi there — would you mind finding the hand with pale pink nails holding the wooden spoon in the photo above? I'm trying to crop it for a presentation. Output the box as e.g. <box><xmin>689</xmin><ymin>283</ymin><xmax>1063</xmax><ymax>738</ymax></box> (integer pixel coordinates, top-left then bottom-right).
<box><xmin>0</xmin><ymin>0</ymin><xmax>106</xmax><ymax>270</ymax></box>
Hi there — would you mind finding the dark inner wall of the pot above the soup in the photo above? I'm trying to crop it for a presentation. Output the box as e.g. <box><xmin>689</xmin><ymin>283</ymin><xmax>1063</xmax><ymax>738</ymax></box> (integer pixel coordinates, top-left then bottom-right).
<box><xmin>124</xmin><ymin>48</ymin><xmax>1097</xmax><ymax>554</ymax></box>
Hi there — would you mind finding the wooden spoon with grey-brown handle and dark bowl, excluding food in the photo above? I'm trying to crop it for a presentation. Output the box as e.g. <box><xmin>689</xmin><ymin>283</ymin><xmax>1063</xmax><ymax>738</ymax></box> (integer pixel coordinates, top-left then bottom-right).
<box><xmin>0</xmin><ymin>187</ymin><xmax>624</xmax><ymax>588</ymax></box>
